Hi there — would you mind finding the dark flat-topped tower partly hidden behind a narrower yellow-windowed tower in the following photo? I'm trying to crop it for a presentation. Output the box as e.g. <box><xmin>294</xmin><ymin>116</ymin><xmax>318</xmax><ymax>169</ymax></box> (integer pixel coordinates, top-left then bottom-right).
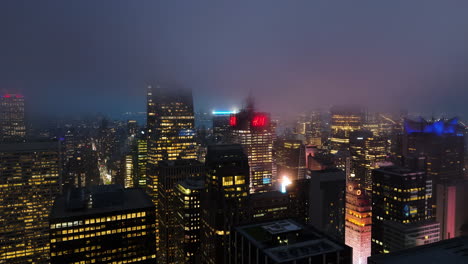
<box><xmin>154</xmin><ymin>160</ymin><xmax>205</xmax><ymax>263</ymax></box>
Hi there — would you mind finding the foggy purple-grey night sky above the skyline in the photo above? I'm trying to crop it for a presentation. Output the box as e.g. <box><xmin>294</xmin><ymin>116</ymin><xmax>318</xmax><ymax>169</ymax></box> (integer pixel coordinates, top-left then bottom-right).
<box><xmin>0</xmin><ymin>0</ymin><xmax>468</xmax><ymax>119</ymax></box>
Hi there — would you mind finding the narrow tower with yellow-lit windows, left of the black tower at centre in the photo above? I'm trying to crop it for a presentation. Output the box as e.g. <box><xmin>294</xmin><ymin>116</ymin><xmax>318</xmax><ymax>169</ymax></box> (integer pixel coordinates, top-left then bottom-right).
<box><xmin>174</xmin><ymin>178</ymin><xmax>205</xmax><ymax>264</ymax></box>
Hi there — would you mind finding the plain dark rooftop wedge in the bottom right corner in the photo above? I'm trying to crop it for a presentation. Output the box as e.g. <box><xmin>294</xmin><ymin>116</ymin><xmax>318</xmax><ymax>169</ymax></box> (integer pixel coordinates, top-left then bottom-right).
<box><xmin>368</xmin><ymin>236</ymin><xmax>468</xmax><ymax>264</ymax></box>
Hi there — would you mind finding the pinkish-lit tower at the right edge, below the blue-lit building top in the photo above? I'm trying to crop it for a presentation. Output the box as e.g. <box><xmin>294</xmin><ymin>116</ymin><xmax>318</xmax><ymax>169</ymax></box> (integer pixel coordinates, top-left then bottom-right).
<box><xmin>436</xmin><ymin>179</ymin><xmax>468</xmax><ymax>239</ymax></box>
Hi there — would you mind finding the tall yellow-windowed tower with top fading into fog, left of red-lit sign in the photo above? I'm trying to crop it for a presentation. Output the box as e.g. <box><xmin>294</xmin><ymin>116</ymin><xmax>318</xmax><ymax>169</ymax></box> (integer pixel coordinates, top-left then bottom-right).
<box><xmin>147</xmin><ymin>85</ymin><xmax>197</xmax><ymax>165</ymax></box>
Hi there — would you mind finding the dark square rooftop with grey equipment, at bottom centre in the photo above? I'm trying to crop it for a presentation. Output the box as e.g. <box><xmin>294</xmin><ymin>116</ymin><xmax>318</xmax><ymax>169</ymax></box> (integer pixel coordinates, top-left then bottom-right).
<box><xmin>235</xmin><ymin>219</ymin><xmax>347</xmax><ymax>263</ymax></box>
